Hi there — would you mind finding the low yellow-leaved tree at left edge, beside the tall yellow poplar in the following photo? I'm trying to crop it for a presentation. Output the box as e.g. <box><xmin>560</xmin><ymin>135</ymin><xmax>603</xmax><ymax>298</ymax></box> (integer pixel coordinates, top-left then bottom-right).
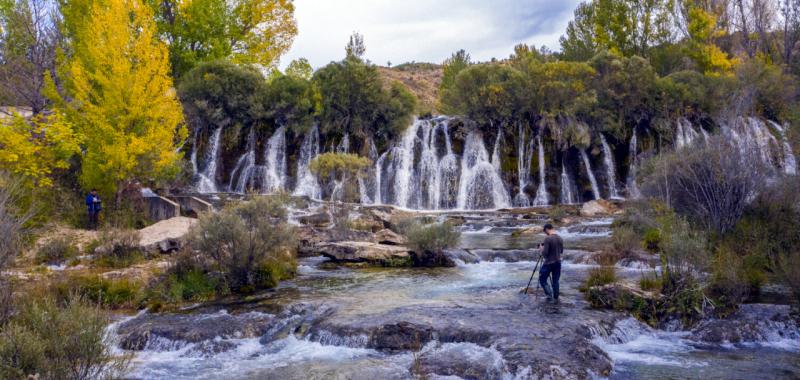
<box><xmin>0</xmin><ymin>113</ymin><xmax>80</xmax><ymax>187</ymax></box>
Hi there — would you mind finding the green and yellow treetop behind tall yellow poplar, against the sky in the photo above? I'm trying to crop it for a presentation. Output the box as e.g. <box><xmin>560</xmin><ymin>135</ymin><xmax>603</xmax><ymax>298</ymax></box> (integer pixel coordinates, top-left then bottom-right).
<box><xmin>147</xmin><ymin>0</ymin><xmax>297</xmax><ymax>78</ymax></box>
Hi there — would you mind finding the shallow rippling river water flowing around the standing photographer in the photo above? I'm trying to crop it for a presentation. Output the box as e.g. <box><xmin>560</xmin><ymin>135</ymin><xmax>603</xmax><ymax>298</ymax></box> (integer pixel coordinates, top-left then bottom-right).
<box><xmin>110</xmin><ymin>213</ymin><xmax>800</xmax><ymax>380</ymax></box>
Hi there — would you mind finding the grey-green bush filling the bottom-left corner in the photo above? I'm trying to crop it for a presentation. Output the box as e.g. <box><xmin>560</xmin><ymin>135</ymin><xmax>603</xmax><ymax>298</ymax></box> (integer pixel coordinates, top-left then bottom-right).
<box><xmin>0</xmin><ymin>299</ymin><xmax>130</xmax><ymax>380</ymax></box>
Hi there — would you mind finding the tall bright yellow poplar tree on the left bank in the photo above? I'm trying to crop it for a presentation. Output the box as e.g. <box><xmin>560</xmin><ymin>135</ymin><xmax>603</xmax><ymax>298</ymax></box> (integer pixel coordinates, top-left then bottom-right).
<box><xmin>48</xmin><ymin>0</ymin><xmax>187</xmax><ymax>201</ymax></box>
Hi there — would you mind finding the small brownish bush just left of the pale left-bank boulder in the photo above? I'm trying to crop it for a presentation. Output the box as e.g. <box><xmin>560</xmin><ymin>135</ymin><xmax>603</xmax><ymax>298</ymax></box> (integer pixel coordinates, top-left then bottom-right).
<box><xmin>94</xmin><ymin>229</ymin><xmax>143</xmax><ymax>268</ymax></box>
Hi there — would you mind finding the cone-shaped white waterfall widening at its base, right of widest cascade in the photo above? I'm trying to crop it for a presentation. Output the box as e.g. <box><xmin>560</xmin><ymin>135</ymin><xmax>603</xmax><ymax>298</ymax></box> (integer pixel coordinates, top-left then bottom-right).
<box><xmin>457</xmin><ymin>131</ymin><xmax>510</xmax><ymax>209</ymax></box>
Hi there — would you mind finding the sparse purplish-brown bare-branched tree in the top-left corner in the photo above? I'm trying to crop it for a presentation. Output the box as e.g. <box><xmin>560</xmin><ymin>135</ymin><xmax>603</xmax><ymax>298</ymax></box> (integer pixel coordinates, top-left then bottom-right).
<box><xmin>0</xmin><ymin>0</ymin><xmax>61</xmax><ymax>114</ymax></box>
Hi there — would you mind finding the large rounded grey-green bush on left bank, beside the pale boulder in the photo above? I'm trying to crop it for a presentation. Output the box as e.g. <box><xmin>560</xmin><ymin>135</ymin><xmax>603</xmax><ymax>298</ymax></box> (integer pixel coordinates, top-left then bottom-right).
<box><xmin>189</xmin><ymin>196</ymin><xmax>298</xmax><ymax>293</ymax></box>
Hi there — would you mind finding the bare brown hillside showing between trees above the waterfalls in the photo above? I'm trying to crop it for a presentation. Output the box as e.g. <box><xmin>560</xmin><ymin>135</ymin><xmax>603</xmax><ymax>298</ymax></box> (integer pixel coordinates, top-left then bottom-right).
<box><xmin>378</xmin><ymin>63</ymin><xmax>442</xmax><ymax>114</ymax></box>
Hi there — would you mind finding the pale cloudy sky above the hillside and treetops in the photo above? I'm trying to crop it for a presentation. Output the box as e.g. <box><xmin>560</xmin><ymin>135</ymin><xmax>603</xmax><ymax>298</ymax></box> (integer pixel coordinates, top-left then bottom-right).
<box><xmin>281</xmin><ymin>0</ymin><xmax>579</xmax><ymax>68</ymax></box>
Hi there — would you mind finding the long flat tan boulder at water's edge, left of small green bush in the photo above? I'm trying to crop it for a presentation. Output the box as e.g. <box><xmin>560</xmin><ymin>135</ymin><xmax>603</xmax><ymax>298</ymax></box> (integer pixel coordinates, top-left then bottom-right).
<box><xmin>314</xmin><ymin>241</ymin><xmax>413</xmax><ymax>267</ymax></box>
